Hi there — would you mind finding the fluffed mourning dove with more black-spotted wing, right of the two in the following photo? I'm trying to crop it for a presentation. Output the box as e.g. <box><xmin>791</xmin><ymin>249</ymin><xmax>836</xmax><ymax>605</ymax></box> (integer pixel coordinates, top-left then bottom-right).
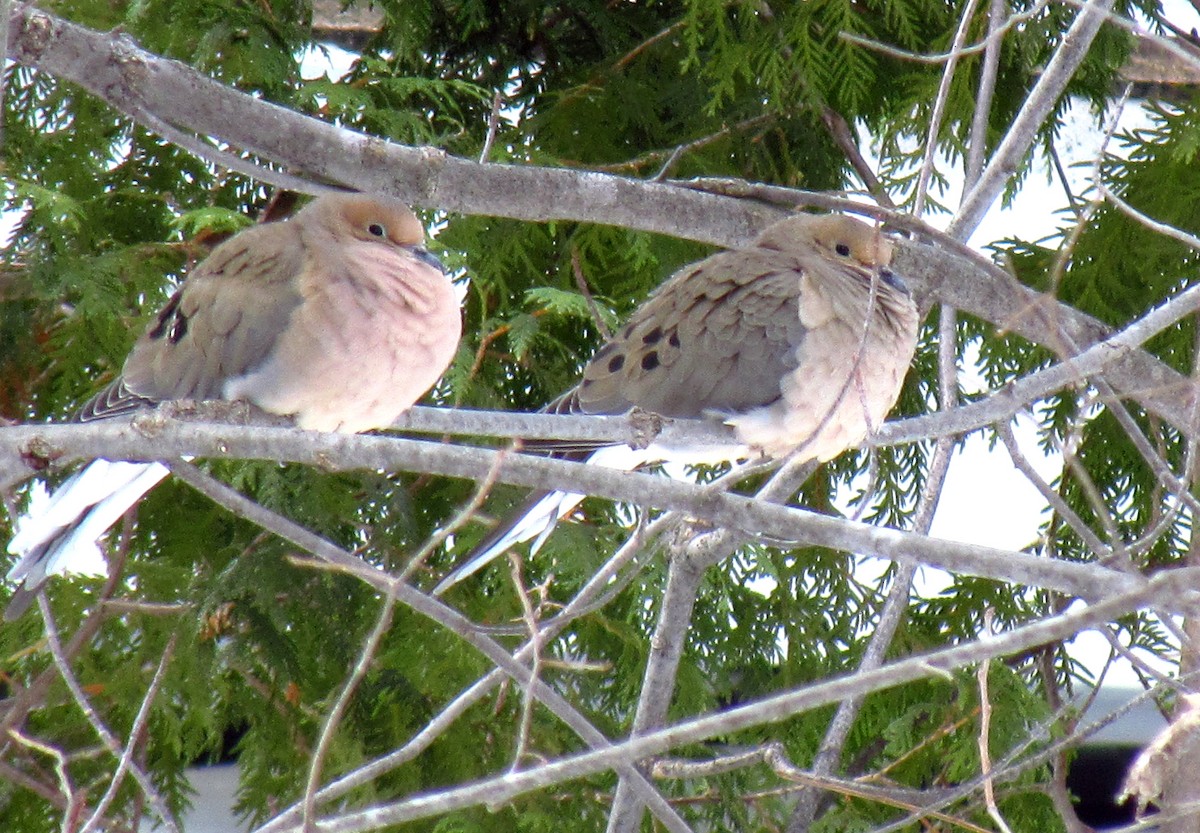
<box><xmin>434</xmin><ymin>214</ymin><xmax>920</xmax><ymax>593</ymax></box>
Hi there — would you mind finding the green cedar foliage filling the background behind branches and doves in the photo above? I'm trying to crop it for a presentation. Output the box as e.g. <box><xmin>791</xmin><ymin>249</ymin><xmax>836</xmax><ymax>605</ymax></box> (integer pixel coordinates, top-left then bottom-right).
<box><xmin>0</xmin><ymin>0</ymin><xmax>1200</xmax><ymax>832</ymax></box>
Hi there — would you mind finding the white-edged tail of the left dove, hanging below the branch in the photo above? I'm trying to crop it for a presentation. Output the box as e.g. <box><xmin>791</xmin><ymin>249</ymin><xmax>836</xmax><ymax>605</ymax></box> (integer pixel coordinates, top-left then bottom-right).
<box><xmin>4</xmin><ymin>460</ymin><xmax>168</xmax><ymax>622</ymax></box>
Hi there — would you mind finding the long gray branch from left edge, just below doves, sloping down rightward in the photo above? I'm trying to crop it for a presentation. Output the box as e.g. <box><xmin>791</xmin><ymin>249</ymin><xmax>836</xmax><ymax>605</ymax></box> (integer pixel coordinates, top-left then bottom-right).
<box><xmin>0</xmin><ymin>415</ymin><xmax>1161</xmax><ymax>599</ymax></box>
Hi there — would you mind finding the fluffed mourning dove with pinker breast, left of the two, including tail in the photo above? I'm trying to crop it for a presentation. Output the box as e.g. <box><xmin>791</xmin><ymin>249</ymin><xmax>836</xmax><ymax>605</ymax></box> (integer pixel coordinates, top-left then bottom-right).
<box><xmin>5</xmin><ymin>194</ymin><xmax>462</xmax><ymax>619</ymax></box>
